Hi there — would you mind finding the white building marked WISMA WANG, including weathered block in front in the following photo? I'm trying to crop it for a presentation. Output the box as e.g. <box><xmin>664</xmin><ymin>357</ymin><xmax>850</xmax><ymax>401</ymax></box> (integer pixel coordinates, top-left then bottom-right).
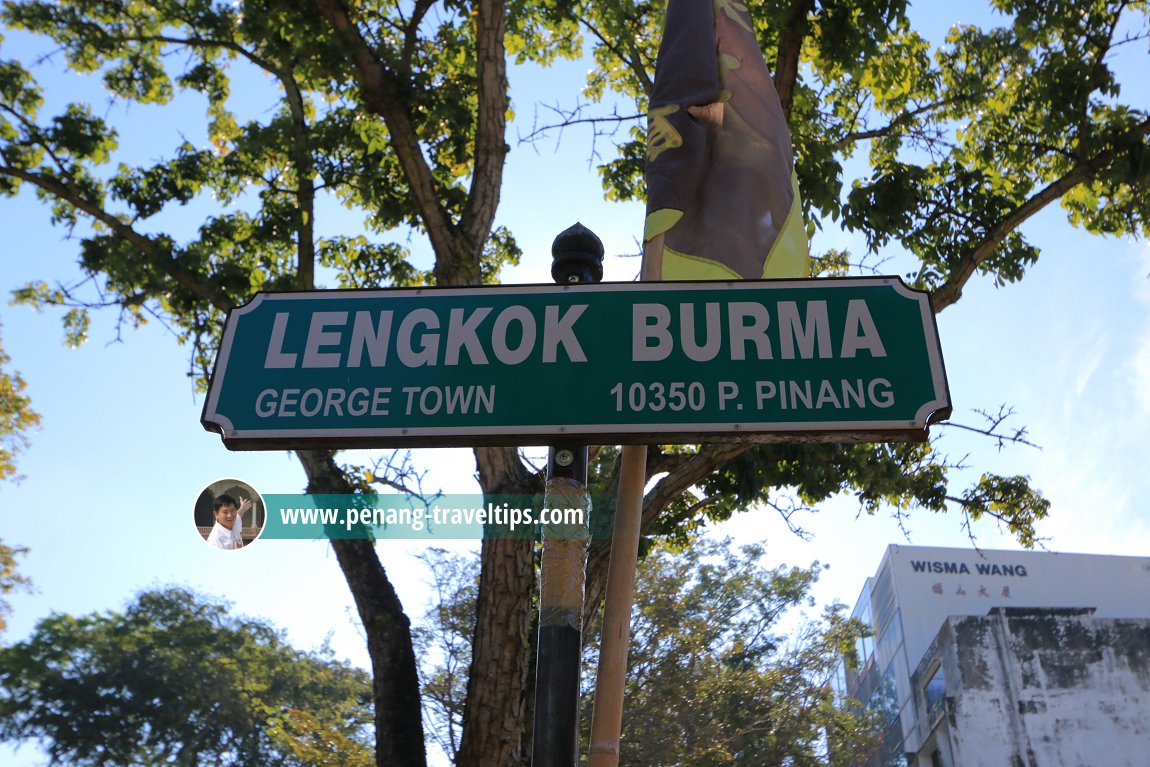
<box><xmin>841</xmin><ymin>545</ymin><xmax>1150</xmax><ymax>767</ymax></box>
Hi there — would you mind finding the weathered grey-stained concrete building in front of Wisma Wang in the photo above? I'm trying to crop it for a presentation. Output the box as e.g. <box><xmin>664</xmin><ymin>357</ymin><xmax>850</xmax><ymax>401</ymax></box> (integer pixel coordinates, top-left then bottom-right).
<box><xmin>938</xmin><ymin>609</ymin><xmax>1150</xmax><ymax>767</ymax></box>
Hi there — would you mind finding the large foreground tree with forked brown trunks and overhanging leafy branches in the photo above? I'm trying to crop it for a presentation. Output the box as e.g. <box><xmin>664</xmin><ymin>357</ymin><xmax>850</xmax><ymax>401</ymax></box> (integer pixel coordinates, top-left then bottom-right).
<box><xmin>0</xmin><ymin>0</ymin><xmax>1150</xmax><ymax>767</ymax></box>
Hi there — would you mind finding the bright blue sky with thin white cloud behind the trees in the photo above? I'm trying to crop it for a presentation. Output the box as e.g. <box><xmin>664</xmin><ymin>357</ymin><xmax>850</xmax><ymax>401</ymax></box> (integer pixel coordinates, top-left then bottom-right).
<box><xmin>0</xmin><ymin>3</ymin><xmax>1150</xmax><ymax>764</ymax></box>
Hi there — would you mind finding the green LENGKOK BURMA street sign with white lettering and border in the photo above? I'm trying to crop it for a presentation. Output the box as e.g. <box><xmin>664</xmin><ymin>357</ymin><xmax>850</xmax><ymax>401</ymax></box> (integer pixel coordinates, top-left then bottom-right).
<box><xmin>202</xmin><ymin>277</ymin><xmax>951</xmax><ymax>450</ymax></box>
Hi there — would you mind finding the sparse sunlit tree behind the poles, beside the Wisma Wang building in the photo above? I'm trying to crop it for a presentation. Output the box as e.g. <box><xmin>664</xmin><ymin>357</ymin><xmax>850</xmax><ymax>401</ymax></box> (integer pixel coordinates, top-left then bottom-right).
<box><xmin>415</xmin><ymin>538</ymin><xmax>876</xmax><ymax>767</ymax></box>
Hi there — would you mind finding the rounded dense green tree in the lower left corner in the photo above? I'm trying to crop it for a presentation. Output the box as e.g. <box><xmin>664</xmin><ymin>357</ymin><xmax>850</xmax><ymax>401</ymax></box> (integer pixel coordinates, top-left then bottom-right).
<box><xmin>0</xmin><ymin>588</ymin><xmax>371</xmax><ymax>767</ymax></box>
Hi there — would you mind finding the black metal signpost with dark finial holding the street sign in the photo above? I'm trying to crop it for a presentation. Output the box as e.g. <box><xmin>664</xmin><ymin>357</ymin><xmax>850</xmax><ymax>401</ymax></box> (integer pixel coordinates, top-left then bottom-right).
<box><xmin>531</xmin><ymin>224</ymin><xmax>603</xmax><ymax>767</ymax></box>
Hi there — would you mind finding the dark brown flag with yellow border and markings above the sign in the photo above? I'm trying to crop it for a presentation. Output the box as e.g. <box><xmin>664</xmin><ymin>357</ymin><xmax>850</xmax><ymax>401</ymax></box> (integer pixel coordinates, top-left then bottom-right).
<box><xmin>643</xmin><ymin>0</ymin><xmax>810</xmax><ymax>279</ymax></box>
